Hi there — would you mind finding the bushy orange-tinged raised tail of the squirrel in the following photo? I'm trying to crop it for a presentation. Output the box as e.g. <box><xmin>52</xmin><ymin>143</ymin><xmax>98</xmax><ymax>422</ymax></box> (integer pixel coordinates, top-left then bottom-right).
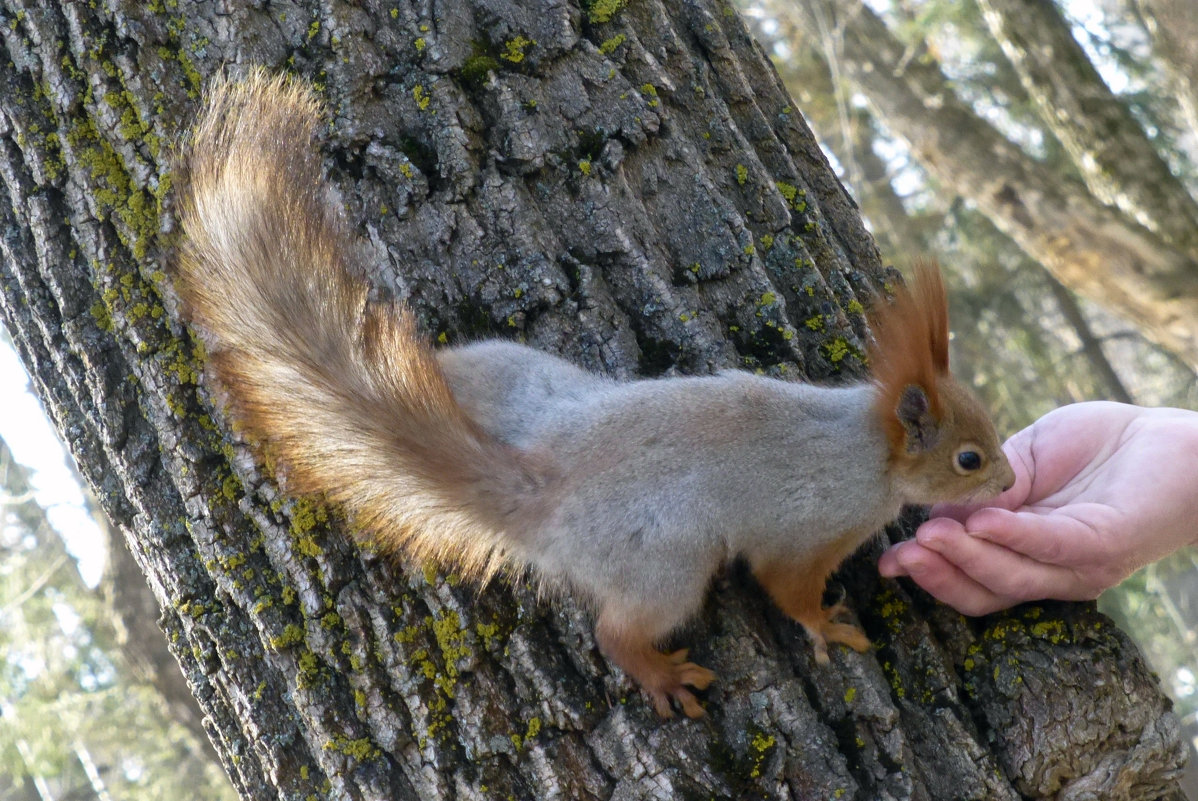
<box><xmin>176</xmin><ymin>71</ymin><xmax>547</xmax><ymax>578</ymax></box>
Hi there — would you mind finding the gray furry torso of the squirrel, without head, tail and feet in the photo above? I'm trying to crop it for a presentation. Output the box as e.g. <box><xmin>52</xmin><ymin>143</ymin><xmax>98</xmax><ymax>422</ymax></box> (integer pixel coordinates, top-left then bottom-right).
<box><xmin>438</xmin><ymin>341</ymin><xmax>901</xmax><ymax>633</ymax></box>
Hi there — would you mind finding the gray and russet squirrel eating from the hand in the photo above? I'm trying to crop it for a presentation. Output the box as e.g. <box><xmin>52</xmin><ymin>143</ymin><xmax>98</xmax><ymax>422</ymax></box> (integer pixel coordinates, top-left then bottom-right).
<box><xmin>174</xmin><ymin>69</ymin><xmax>1014</xmax><ymax>717</ymax></box>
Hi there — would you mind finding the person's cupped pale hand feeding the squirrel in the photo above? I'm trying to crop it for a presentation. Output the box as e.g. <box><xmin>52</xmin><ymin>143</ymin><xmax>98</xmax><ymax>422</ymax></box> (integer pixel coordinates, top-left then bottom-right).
<box><xmin>878</xmin><ymin>402</ymin><xmax>1198</xmax><ymax>614</ymax></box>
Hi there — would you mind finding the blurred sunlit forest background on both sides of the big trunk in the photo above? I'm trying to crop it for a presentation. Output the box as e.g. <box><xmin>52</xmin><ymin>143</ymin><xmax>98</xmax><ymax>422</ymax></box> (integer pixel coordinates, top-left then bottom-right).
<box><xmin>0</xmin><ymin>0</ymin><xmax>1198</xmax><ymax>801</ymax></box>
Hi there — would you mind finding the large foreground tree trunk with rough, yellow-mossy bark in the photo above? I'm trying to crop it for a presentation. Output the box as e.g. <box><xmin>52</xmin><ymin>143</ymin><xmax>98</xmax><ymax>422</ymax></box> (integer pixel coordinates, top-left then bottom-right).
<box><xmin>0</xmin><ymin>0</ymin><xmax>1181</xmax><ymax>801</ymax></box>
